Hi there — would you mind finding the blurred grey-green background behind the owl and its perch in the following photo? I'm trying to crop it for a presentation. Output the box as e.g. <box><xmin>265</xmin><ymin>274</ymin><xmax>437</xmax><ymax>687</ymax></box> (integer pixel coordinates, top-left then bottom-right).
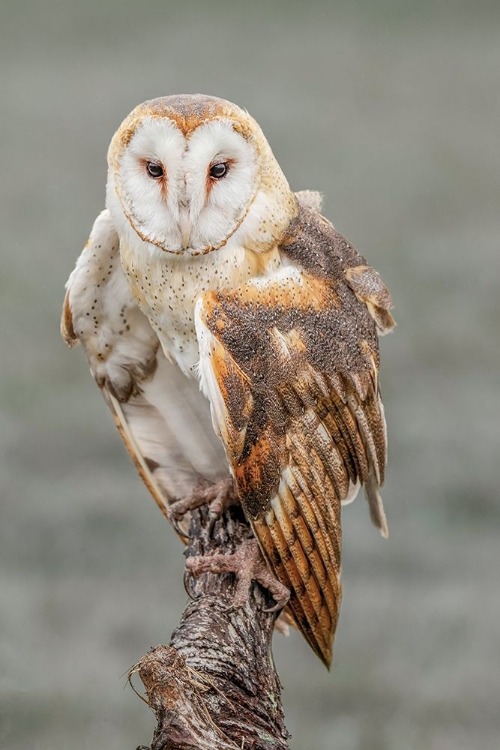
<box><xmin>0</xmin><ymin>0</ymin><xmax>500</xmax><ymax>750</ymax></box>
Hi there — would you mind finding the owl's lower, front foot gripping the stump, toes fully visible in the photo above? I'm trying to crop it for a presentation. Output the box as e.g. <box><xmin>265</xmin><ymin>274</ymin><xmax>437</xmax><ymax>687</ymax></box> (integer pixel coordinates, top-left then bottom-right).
<box><xmin>186</xmin><ymin>539</ymin><xmax>290</xmax><ymax>612</ymax></box>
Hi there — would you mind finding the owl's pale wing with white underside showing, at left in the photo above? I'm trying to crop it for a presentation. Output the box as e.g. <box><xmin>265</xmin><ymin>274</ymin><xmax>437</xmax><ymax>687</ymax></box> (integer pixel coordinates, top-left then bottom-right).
<box><xmin>61</xmin><ymin>211</ymin><xmax>228</xmax><ymax>528</ymax></box>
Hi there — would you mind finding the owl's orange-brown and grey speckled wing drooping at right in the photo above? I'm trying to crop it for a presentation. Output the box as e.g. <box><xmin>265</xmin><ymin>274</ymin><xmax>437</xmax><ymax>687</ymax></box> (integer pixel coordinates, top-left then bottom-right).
<box><xmin>196</xmin><ymin>207</ymin><xmax>391</xmax><ymax>665</ymax></box>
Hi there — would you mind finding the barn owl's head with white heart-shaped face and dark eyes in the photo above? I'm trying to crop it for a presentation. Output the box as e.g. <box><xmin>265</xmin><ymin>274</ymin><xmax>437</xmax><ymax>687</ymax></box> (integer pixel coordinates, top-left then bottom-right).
<box><xmin>107</xmin><ymin>94</ymin><xmax>297</xmax><ymax>255</ymax></box>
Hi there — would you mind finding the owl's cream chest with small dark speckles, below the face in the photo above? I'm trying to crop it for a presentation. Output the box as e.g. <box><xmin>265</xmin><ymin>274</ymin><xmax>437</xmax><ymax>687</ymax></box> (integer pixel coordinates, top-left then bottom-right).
<box><xmin>120</xmin><ymin>241</ymin><xmax>281</xmax><ymax>376</ymax></box>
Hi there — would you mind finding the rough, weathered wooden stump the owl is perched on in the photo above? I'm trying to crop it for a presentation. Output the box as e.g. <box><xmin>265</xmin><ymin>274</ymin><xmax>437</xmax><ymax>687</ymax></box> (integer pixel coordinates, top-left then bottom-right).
<box><xmin>132</xmin><ymin>507</ymin><xmax>288</xmax><ymax>750</ymax></box>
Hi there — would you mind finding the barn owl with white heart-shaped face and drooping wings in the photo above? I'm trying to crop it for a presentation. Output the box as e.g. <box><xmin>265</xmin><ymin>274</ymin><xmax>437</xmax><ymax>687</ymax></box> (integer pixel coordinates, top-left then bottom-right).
<box><xmin>62</xmin><ymin>95</ymin><xmax>394</xmax><ymax>665</ymax></box>
